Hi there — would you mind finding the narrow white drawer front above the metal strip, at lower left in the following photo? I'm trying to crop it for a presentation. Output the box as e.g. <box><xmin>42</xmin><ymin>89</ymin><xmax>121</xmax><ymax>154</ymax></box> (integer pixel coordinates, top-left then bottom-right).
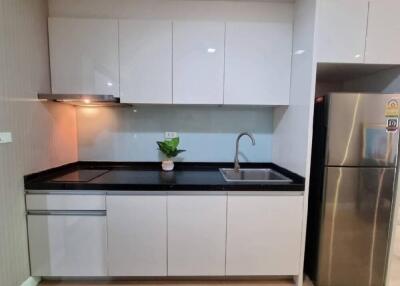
<box><xmin>26</xmin><ymin>194</ymin><xmax>106</xmax><ymax>211</ymax></box>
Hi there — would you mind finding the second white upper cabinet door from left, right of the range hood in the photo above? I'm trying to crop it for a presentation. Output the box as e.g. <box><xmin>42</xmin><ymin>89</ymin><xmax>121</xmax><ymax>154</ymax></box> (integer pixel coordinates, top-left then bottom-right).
<box><xmin>119</xmin><ymin>20</ymin><xmax>172</xmax><ymax>104</ymax></box>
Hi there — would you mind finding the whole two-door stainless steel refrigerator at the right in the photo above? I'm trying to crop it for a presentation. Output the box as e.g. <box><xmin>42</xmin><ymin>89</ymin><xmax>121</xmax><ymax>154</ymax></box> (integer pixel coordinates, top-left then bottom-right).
<box><xmin>305</xmin><ymin>93</ymin><xmax>400</xmax><ymax>286</ymax></box>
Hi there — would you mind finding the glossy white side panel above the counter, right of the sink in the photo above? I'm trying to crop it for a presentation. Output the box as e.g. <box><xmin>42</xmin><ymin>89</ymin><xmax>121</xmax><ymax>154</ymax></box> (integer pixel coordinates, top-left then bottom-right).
<box><xmin>272</xmin><ymin>0</ymin><xmax>316</xmax><ymax>176</ymax></box>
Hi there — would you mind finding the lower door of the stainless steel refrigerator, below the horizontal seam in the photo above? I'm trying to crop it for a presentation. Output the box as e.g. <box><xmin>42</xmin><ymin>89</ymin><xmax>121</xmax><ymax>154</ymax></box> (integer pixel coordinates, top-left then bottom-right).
<box><xmin>316</xmin><ymin>167</ymin><xmax>396</xmax><ymax>286</ymax></box>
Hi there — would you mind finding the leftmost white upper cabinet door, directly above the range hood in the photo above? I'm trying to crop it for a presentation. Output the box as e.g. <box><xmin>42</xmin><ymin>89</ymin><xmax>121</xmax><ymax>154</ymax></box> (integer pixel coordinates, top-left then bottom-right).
<box><xmin>49</xmin><ymin>18</ymin><xmax>119</xmax><ymax>96</ymax></box>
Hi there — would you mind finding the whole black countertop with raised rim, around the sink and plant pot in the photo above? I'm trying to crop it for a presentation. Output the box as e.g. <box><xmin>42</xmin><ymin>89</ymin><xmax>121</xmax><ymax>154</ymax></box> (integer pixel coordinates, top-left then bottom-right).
<box><xmin>24</xmin><ymin>161</ymin><xmax>304</xmax><ymax>192</ymax></box>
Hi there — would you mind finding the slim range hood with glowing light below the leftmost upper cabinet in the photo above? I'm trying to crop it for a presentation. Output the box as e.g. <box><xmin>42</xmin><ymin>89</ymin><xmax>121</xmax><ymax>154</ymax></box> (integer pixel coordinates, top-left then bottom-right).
<box><xmin>38</xmin><ymin>93</ymin><xmax>124</xmax><ymax>106</ymax></box>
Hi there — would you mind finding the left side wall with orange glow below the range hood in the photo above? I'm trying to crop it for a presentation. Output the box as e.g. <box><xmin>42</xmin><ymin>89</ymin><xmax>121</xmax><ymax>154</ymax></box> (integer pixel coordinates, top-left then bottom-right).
<box><xmin>0</xmin><ymin>0</ymin><xmax>77</xmax><ymax>286</ymax></box>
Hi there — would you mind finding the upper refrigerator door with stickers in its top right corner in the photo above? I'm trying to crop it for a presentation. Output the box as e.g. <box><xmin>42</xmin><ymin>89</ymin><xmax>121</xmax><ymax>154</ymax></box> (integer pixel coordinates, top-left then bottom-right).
<box><xmin>325</xmin><ymin>93</ymin><xmax>400</xmax><ymax>167</ymax></box>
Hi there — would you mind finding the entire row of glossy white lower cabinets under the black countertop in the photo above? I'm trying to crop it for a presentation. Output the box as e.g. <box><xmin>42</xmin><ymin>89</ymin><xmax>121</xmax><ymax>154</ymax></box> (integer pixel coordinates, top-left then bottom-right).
<box><xmin>27</xmin><ymin>192</ymin><xmax>303</xmax><ymax>277</ymax></box>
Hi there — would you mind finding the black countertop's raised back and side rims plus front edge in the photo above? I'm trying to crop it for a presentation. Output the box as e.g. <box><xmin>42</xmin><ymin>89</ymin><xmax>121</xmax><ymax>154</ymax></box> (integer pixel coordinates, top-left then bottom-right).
<box><xmin>24</xmin><ymin>161</ymin><xmax>305</xmax><ymax>194</ymax></box>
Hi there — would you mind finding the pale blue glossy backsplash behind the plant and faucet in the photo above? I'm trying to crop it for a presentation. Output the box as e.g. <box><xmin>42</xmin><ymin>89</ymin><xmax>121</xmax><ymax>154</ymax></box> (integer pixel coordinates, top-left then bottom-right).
<box><xmin>77</xmin><ymin>106</ymin><xmax>273</xmax><ymax>162</ymax></box>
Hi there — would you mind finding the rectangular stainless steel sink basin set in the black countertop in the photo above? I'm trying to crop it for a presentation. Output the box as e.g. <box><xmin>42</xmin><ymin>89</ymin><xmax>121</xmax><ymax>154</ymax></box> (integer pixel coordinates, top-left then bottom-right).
<box><xmin>220</xmin><ymin>169</ymin><xmax>292</xmax><ymax>184</ymax></box>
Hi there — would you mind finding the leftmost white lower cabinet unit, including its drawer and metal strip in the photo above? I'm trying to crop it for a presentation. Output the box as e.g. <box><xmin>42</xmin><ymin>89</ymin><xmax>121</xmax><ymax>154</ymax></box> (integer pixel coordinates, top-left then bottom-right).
<box><xmin>26</xmin><ymin>193</ymin><xmax>107</xmax><ymax>277</ymax></box>
